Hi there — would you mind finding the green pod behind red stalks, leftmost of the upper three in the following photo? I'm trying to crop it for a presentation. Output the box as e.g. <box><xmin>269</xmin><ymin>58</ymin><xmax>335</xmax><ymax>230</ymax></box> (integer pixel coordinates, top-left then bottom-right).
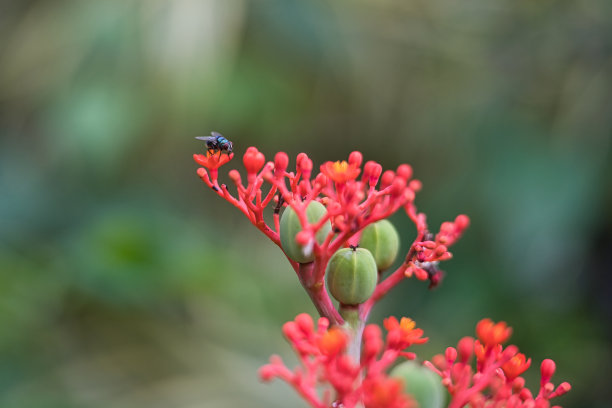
<box><xmin>280</xmin><ymin>201</ymin><xmax>331</xmax><ymax>263</ymax></box>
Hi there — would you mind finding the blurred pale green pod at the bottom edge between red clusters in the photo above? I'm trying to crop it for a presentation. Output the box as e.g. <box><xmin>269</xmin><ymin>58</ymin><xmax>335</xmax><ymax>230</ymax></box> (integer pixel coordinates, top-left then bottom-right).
<box><xmin>391</xmin><ymin>361</ymin><xmax>446</xmax><ymax>408</ymax></box>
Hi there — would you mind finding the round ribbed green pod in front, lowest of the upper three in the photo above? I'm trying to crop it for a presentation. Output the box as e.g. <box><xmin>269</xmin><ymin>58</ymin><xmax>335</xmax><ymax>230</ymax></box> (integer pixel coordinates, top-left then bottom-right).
<box><xmin>325</xmin><ymin>248</ymin><xmax>378</xmax><ymax>305</ymax></box>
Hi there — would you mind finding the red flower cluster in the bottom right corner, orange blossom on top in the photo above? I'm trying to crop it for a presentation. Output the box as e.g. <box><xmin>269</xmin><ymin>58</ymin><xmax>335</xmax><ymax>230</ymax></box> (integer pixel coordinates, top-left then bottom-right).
<box><xmin>425</xmin><ymin>319</ymin><xmax>571</xmax><ymax>408</ymax></box>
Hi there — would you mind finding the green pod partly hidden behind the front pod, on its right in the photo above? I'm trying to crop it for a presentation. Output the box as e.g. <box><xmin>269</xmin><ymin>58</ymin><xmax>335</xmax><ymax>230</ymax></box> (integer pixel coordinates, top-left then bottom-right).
<box><xmin>359</xmin><ymin>220</ymin><xmax>399</xmax><ymax>271</ymax></box>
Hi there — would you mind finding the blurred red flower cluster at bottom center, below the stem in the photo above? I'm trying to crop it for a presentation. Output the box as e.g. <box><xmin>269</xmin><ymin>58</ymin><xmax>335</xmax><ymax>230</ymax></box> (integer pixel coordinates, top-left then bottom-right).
<box><xmin>259</xmin><ymin>314</ymin><xmax>427</xmax><ymax>408</ymax></box>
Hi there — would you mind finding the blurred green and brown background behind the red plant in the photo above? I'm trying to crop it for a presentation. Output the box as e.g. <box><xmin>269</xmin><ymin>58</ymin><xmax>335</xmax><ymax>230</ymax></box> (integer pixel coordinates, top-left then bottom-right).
<box><xmin>0</xmin><ymin>0</ymin><xmax>612</xmax><ymax>408</ymax></box>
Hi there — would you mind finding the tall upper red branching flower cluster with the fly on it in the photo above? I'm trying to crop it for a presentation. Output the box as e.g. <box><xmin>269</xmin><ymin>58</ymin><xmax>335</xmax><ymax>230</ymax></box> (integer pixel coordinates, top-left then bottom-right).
<box><xmin>194</xmin><ymin>147</ymin><xmax>469</xmax><ymax>323</ymax></box>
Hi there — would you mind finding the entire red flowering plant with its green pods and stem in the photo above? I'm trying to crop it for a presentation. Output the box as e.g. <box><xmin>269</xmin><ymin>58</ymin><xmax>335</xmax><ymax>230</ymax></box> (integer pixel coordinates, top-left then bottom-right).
<box><xmin>194</xmin><ymin>141</ymin><xmax>570</xmax><ymax>408</ymax></box>
